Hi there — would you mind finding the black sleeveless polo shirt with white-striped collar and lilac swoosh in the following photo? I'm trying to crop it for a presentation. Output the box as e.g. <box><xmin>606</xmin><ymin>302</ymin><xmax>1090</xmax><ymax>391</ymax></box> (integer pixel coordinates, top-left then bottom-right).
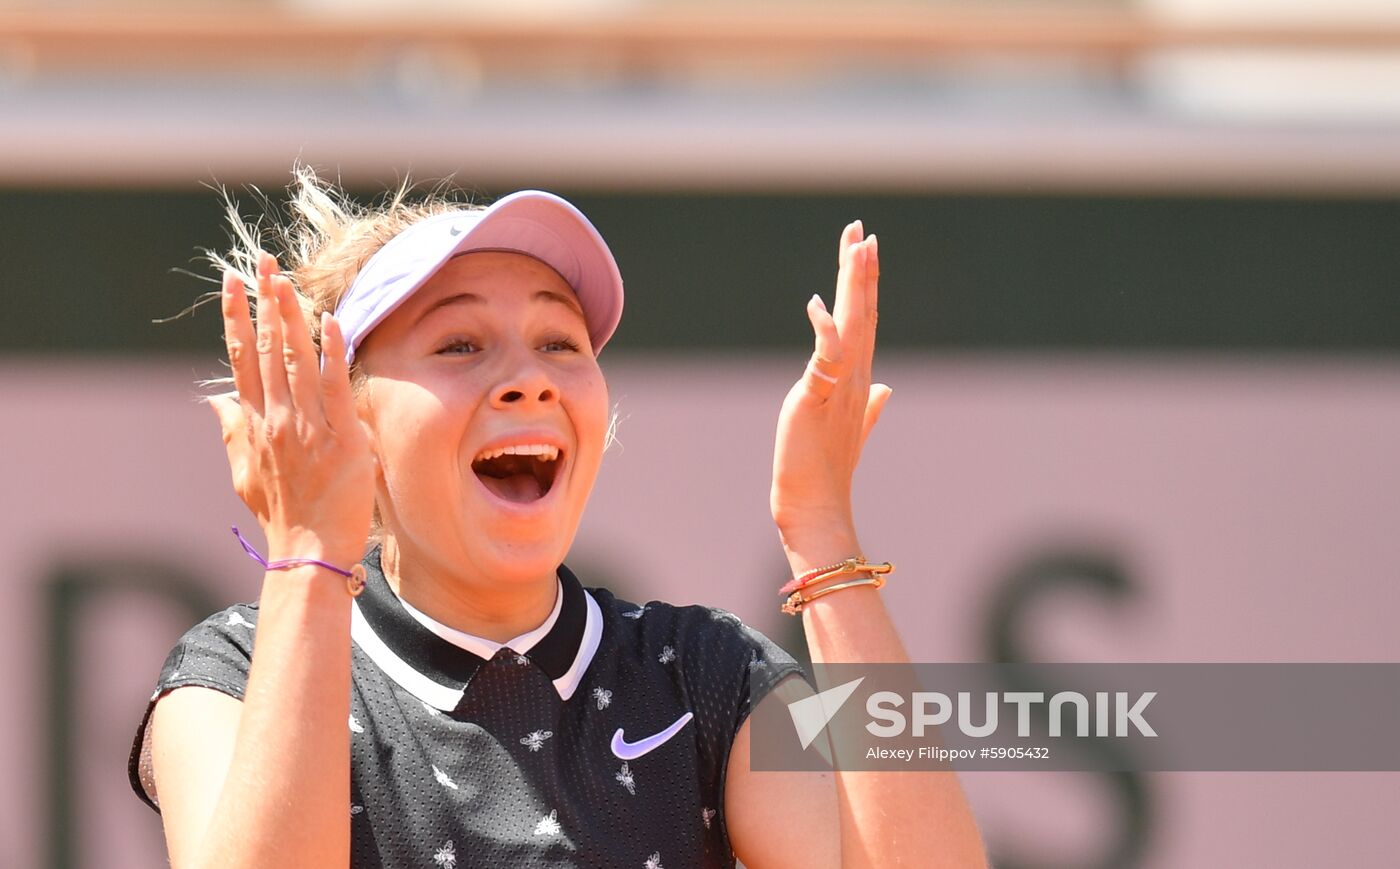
<box><xmin>130</xmin><ymin>547</ymin><xmax>801</xmax><ymax>869</ymax></box>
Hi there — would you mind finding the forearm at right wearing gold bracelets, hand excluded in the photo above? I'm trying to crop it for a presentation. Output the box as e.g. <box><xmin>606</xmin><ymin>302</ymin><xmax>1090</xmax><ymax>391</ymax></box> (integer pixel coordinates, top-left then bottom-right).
<box><xmin>785</xmin><ymin>535</ymin><xmax>987</xmax><ymax>869</ymax></box>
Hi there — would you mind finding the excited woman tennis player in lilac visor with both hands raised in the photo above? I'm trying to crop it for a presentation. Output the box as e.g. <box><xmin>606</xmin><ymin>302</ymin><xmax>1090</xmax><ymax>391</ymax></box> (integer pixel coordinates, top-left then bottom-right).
<box><xmin>132</xmin><ymin>171</ymin><xmax>986</xmax><ymax>869</ymax></box>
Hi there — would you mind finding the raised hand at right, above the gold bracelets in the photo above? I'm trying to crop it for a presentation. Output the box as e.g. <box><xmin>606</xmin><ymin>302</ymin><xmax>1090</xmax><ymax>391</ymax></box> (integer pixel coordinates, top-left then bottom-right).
<box><xmin>770</xmin><ymin>221</ymin><xmax>890</xmax><ymax>561</ymax></box>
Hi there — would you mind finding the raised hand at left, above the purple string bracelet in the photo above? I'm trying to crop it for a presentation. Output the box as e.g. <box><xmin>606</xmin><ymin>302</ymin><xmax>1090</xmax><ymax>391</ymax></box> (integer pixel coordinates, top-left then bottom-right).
<box><xmin>209</xmin><ymin>253</ymin><xmax>374</xmax><ymax>568</ymax></box>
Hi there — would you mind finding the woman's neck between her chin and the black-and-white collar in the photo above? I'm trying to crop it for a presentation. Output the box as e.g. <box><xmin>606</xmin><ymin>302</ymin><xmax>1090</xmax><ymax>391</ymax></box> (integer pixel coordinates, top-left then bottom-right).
<box><xmin>379</xmin><ymin>532</ymin><xmax>559</xmax><ymax>642</ymax></box>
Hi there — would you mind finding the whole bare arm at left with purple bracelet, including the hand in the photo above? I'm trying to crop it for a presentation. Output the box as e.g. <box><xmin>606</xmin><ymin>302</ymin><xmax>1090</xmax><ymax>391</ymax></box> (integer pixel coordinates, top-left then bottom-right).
<box><xmin>151</xmin><ymin>255</ymin><xmax>374</xmax><ymax>869</ymax></box>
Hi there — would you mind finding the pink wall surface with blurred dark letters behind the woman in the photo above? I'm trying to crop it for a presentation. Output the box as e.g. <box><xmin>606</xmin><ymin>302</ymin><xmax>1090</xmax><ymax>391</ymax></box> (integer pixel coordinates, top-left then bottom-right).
<box><xmin>0</xmin><ymin>354</ymin><xmax>1400</xmax><ymax>869</ymax></box>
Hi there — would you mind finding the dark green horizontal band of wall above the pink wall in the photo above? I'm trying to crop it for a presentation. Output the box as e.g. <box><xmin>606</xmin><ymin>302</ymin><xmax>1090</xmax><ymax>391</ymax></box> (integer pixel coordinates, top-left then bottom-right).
<box><xmin>0</xmin><ymin>189</ymin><xmax>1400</xmax><ymax>355</ymax></box>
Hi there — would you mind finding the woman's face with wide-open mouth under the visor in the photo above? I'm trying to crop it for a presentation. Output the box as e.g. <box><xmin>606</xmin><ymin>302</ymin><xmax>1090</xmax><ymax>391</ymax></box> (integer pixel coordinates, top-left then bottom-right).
<box><xmin>357</xmin><ymin>252</ymin><xmax>608</xmax><ymax>582</ymax></box>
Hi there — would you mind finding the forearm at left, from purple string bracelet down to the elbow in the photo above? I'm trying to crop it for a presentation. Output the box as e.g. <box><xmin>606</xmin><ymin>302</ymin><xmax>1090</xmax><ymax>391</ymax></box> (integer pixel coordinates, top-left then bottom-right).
<box><xmin>187</xmin><ymin>565</ymin><xmax>351</xmax><ymax>869</ymax></box>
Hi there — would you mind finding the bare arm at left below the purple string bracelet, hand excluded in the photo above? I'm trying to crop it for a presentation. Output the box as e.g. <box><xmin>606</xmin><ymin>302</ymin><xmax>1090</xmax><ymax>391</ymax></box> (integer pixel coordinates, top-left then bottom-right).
<box><xmin>151</xmin><ymin>567</ymin><xmax>350</xmax><ymax>869</ymax></box>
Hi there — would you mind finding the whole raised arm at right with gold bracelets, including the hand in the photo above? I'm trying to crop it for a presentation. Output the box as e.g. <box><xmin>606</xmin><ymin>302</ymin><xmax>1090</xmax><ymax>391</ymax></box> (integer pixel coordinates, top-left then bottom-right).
<box><xmin>725</xmin><ymin>221</ymin><xmax>987</xmax><ymax>869</ymax></box>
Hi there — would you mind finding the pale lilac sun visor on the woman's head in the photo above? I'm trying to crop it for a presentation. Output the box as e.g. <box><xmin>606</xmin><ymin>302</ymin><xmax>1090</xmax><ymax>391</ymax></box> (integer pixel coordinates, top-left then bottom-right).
<box><xmin>336</xmin><ymin>190</ymin><xmax>622</xmax><ymax>365</ymax></box>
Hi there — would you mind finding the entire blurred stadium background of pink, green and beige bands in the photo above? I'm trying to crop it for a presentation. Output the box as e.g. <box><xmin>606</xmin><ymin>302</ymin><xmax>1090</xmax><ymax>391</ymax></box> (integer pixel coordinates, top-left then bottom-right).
<box><xmin>0</xmin><ymin>0</ymin><xmax>1400</xmax><ymax>869</ymax></box>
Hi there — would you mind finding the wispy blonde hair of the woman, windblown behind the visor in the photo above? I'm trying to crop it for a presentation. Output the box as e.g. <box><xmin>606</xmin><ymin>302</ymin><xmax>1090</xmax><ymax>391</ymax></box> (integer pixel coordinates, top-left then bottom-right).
<box><xmin>196</xmin><ymin>162</ymin><xmax>619</xmax><ymax>543</ymax></box>
